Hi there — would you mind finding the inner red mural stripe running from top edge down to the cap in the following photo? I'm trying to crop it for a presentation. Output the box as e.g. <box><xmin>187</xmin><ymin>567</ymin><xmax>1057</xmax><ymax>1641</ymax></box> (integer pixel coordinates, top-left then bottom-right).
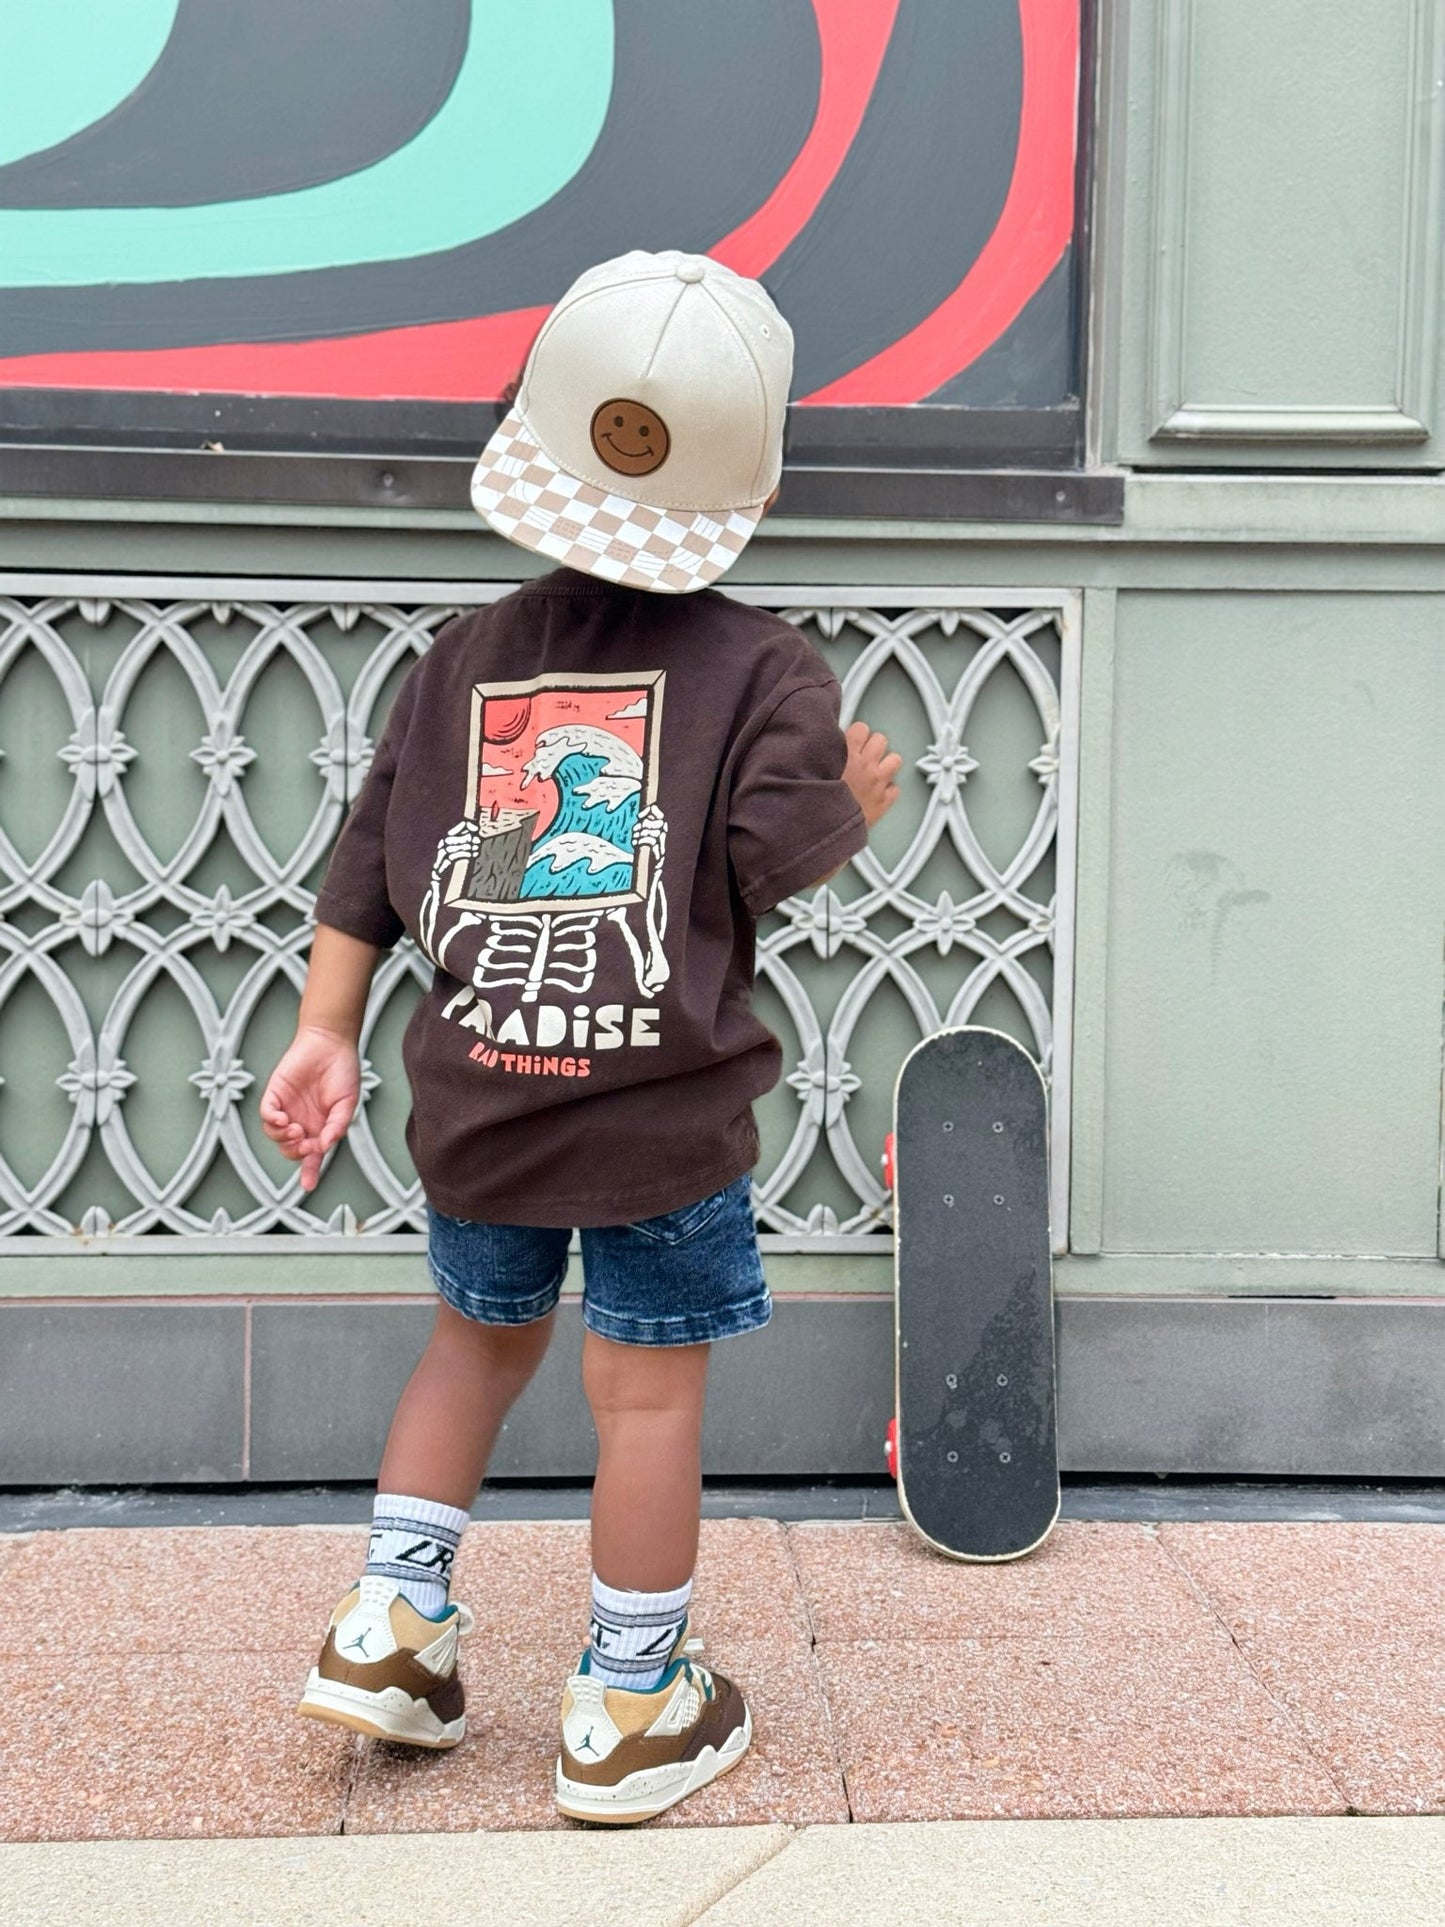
<box><xmin>709</xmin><ymin>0</ymin><xmax>898</xmax><ymax>276</ymax></box>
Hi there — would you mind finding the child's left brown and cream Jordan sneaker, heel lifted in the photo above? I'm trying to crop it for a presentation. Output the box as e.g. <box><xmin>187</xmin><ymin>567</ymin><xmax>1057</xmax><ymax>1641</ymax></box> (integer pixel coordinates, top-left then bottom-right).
<box><xmin>297</xmin><ymin>1572</ymin><xmax>476</xmax><ymax>1748</ymax></box>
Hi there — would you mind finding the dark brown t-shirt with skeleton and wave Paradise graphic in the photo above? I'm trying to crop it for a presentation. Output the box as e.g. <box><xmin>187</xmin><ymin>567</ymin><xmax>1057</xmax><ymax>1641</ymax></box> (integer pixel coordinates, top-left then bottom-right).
<box><xmin>316</xmin><ymin>568</ymin><xmax>865</xmax><ymax>1226</ymax></box>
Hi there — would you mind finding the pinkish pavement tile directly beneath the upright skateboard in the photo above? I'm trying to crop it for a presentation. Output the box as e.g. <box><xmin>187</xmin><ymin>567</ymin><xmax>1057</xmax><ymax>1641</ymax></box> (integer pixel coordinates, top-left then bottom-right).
<box><xmin>788</xmin><ymin>1520</ymin><xmax>1210</xmax><ymax>1640</ymax></box>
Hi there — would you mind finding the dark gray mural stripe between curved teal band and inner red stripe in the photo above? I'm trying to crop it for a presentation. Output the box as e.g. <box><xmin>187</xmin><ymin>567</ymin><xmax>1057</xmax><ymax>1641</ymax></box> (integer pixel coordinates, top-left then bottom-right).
<box><xmin>0</xmin><ymin>0</ymin><xmax>820</xmax><ymax>355</ymax></box>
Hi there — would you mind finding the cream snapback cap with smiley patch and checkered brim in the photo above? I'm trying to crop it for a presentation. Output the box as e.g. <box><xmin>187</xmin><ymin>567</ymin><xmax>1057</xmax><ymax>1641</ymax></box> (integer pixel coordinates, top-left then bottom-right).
<box><xmin>472</xmin><ymin>251</ymin><xmax>792</xmax><ymax>595</ymax></box>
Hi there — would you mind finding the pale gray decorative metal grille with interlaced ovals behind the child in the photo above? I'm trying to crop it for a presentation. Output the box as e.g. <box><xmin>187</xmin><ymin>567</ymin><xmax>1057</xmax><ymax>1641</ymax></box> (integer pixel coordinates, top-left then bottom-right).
<box><xmin>0</xmin><ymin>578</ymin><xmax>1077</xmax><ymax>1254</ymax></box>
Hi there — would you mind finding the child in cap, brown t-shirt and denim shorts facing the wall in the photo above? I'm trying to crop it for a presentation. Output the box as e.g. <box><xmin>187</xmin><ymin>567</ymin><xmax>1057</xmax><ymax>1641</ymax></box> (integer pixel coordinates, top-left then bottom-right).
<box><xmin>260</xmin><ymin>252</ymin><xmax>900</xmax><ymax>1823</ymax></box>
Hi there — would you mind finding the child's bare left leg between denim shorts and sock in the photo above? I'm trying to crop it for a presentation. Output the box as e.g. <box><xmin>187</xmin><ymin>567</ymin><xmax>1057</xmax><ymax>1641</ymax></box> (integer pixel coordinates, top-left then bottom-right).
<box><xmin>378</xmin><ymin>1299</ymin><xmax>557</xmax><ymax>1511</ymax></box>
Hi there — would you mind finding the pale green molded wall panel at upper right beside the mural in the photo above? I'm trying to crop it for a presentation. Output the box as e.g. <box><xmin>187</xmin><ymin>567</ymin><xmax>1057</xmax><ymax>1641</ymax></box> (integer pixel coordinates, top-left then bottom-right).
<box><xmin>1119</xmin><ymin>0</ymin><xmax>1445</xmax><ymax>468</ymax></box>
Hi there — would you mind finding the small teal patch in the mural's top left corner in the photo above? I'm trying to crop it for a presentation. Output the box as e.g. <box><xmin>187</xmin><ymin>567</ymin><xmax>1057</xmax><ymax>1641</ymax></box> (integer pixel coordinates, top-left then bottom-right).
<box><xmin>0</xmin><ymin>0</ymin><xmax>179</xmax><ymax>168</ymax></box>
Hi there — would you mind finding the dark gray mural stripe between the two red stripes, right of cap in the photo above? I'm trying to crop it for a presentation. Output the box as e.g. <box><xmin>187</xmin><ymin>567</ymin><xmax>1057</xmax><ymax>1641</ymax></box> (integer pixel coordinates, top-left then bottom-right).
<box><xmin>763</xmin><ymin>0</ymin><xmax>1023</xmax><ymax>395</ymax></box>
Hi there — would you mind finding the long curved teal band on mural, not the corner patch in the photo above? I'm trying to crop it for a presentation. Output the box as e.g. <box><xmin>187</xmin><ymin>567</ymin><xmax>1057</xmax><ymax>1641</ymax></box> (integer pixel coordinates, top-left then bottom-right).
<box><xmin>0</xmin><ymin>0</ymin><xmax>613</xmax><ymax>287</ymax></box>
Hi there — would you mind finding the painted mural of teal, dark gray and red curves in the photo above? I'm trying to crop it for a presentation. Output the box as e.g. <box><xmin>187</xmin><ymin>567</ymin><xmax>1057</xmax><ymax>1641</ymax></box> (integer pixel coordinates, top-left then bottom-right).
<box><xmin>0</xmin><ymin>0</ymin><xmax>1079</xmax><ymax>420</ymax></box>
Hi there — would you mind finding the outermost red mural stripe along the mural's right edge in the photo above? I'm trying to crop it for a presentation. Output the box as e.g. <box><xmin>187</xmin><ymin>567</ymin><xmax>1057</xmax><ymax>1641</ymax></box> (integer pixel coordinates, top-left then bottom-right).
<box><xmin>801</xmin><ymin>0</ymin><xmax>1079</xmax><ymax>407</ymax></box>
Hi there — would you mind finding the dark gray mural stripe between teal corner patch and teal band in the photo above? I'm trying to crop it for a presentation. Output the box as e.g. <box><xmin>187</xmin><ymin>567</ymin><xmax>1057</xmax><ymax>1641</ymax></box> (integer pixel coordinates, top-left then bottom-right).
<box><xmin>0</xmin><ymin>0</ymin><xmax>470</xmax><ymax>208</ymax></box>
